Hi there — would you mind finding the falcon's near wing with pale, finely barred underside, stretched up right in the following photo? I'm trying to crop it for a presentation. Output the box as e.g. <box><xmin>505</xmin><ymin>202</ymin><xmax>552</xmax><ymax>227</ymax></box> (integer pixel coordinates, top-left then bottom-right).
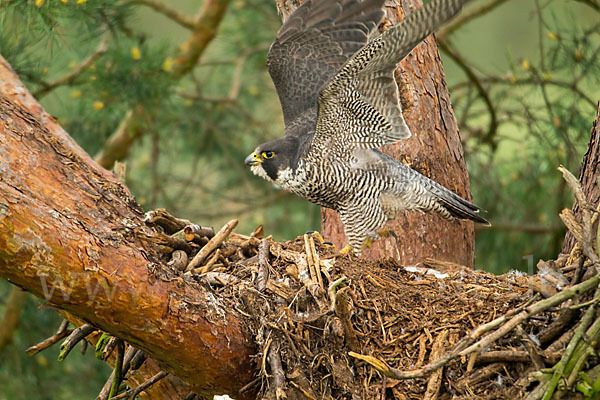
<box><xmin>311</xmin><ymin>0</ymin><xmax>469</xmax><ymax>155</ymax></box>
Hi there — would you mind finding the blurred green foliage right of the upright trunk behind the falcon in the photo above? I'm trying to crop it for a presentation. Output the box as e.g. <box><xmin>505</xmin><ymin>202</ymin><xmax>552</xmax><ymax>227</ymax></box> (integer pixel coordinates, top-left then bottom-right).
<box><xmin>447</xmin><ymin>2</ymin><xmax>600</xmax><ymax>273</ymax></box>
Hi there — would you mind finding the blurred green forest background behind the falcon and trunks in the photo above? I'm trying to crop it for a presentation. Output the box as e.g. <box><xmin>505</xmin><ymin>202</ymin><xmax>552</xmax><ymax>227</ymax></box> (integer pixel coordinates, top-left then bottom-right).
<box><xmin>0</xmin><ymin>0</ymin><xmax>600</xmax><ymax>400</ymax></box>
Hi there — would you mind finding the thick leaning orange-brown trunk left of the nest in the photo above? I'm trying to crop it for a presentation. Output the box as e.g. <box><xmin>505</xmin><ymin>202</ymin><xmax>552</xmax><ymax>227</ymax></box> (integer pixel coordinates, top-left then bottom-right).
<box><xmin>0</xmin><ymin>57</ymin><xmax>254</xmax><ymax>399</ymax></box>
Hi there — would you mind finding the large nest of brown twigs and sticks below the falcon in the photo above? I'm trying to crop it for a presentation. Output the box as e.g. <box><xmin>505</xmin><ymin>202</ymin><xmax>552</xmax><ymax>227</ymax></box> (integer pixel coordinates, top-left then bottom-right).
<box><xmin>149</xmin><ymin>206</ymin><xmax>598</xmax><ymax>399</ymax></box>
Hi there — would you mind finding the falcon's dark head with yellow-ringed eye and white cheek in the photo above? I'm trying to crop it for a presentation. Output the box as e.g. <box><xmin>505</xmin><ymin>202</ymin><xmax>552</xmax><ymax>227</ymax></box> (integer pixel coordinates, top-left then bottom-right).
<box><xmin>244</xmin><ymin>136</ymin><xmax>298</xmax><ymax>185</ymax></box>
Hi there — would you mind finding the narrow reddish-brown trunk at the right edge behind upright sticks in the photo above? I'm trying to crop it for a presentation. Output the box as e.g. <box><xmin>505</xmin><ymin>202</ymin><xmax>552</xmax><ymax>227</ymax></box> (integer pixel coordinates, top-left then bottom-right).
<box><xmin>562</xmin><ymin>103</ymin><xmax>600</xmax><ymax>254</ymax></box>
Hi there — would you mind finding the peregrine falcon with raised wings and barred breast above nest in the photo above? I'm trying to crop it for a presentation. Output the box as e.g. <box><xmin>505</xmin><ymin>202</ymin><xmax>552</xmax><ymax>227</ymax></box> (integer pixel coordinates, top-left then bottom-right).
<box><xmin>245</xmin><ymin>0</ymin><xmax>489</xmax><ymax>253</ymax></box>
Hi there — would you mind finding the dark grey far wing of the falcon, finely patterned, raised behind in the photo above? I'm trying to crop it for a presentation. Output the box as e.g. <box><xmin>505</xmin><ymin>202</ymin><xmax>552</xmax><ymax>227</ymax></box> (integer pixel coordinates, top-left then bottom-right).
<box><xmin>267</xmin><ymin>0</ymin><xmax>385</xmax><ymax>126</ymax></box>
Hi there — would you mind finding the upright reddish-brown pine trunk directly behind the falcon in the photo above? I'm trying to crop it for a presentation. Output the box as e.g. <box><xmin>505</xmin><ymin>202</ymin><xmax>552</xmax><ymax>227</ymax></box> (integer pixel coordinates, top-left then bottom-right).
<box><xmin>321</xmin><ymin>0</ymin><xmax>475</xmax><ymax>267</ymax></box>
